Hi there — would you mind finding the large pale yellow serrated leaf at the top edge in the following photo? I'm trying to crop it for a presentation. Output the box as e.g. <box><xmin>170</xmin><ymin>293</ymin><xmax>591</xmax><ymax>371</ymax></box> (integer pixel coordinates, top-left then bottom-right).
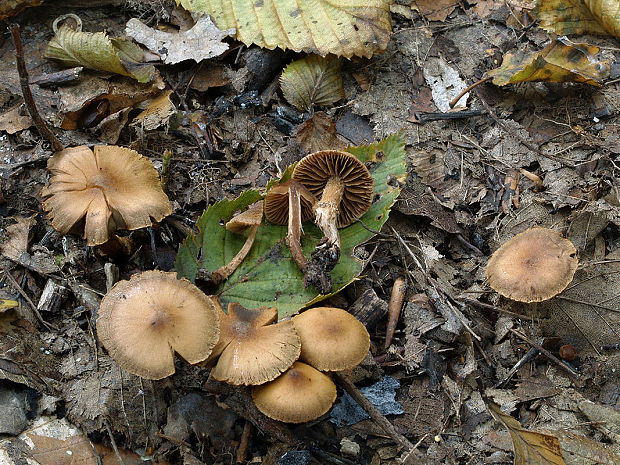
<box><xmin>176</xmin><ymin>0</ymin><xmax>391</xmax><ymax>58</ymax></box>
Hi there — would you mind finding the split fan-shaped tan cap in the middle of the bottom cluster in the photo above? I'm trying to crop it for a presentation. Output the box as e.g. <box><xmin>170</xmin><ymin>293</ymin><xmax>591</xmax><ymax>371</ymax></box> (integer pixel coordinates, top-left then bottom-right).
<box><xmin>211</xmin><ymin>303</ymin><xmax>301</xmax><ymax>386</ymax></box>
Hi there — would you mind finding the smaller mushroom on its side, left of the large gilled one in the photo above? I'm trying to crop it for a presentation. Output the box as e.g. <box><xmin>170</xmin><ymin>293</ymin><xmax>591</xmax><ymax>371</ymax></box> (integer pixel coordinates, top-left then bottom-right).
<box><xmin>265</xmin><ymin>179</ymin><xmax>316</xmax><ymax>278</ymax></box>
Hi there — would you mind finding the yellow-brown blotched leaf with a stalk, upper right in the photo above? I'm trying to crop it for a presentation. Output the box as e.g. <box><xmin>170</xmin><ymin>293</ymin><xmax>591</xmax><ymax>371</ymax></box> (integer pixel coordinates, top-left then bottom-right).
<box><xmin>487</xmin><ymin>40</ymin><xmax>610</xmax><ymax>86</ymax></box>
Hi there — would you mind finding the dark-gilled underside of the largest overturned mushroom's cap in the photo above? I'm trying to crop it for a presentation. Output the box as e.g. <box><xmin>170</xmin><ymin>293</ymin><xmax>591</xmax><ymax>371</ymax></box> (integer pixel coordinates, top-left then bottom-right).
<box><xmin>293</xmin><ymin>150</ymin><xmax>374</xmax><ymax>228</ymax></box>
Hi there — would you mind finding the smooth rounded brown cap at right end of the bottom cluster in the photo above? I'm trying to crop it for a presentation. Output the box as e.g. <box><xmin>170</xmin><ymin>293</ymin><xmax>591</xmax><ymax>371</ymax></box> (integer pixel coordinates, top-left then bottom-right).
<box><xmin>292</xmin><ymin>307</ymin><xmax>370</xmax><ymax>371</ymax></box>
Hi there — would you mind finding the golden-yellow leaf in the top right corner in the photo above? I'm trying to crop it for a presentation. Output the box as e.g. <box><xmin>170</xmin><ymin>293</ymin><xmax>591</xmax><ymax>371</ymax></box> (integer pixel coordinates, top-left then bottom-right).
<box><xmin>532</xmin><ymin>0</ymin><xmax>620</xmax><ymax>37</ymax></box>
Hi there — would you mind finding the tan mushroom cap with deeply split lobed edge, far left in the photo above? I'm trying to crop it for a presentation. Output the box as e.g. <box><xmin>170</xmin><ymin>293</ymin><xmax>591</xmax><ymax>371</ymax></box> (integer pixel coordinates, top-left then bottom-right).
<box><xmin>41</xmin><ymin>145</ymin><xmax>172</xmax><ymax>246</ymax></box>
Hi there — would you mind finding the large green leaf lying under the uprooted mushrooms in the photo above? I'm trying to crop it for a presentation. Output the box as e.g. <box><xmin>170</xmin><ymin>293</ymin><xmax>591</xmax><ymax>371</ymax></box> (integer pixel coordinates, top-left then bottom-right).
<box><xmin>176</xmin><ymin>135</ymin><xmax>407</xmax><ymax>317</ymax></box>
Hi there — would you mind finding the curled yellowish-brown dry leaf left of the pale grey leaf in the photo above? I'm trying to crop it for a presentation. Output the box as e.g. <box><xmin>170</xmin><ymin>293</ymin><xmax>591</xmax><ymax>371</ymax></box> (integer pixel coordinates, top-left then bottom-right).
<box><xmin>45</xmin><ymin>25</ymin><xmax>155</xmax><ymax>82</ymax></box>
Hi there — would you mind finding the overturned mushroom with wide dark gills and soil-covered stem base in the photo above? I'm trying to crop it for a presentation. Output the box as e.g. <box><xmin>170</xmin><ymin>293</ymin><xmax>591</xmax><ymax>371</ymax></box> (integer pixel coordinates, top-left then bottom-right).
<box><xmin>293</xmin><ymin>150</ymin><xmax>374</xmax><ymax>294</ymax></box>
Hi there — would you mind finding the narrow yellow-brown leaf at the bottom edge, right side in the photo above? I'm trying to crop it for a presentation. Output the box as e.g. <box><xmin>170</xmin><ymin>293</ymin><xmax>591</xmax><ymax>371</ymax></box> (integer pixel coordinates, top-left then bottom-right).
<box><xmin>488</xmin><ymin>402</ymin><xmax>566</xmax><ymax>465</ymax></box>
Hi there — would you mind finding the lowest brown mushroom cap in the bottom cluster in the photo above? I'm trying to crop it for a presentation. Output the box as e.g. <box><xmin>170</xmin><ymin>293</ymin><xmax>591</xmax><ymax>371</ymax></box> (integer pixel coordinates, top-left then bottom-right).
<box><xmin>252</xmin><ymin>362</ymin><xmax>336</xmax><ymax>423</ymax></box>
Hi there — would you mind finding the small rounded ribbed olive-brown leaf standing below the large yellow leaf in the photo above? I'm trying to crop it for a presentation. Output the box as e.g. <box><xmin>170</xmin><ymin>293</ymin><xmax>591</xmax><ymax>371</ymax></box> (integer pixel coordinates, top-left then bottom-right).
<box><xmin>280</xmin><ymin>55</ymin><xmax>344</xmax><ymax>111</ymax></box>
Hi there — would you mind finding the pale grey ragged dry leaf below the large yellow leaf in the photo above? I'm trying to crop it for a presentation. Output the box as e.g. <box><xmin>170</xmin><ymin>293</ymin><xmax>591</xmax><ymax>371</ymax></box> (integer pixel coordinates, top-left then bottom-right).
<box><xmin>125</xmin><ymin>16</ymin><xmax>235</xmax><ymax>65</ymax></box>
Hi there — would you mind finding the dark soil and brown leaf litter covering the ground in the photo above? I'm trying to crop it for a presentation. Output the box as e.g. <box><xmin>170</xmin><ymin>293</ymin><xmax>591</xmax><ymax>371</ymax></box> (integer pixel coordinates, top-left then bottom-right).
<box><xmin>0</xmin><ymin>0</ymin><xmax>620</xmax><ymax>465</ymax></box>
